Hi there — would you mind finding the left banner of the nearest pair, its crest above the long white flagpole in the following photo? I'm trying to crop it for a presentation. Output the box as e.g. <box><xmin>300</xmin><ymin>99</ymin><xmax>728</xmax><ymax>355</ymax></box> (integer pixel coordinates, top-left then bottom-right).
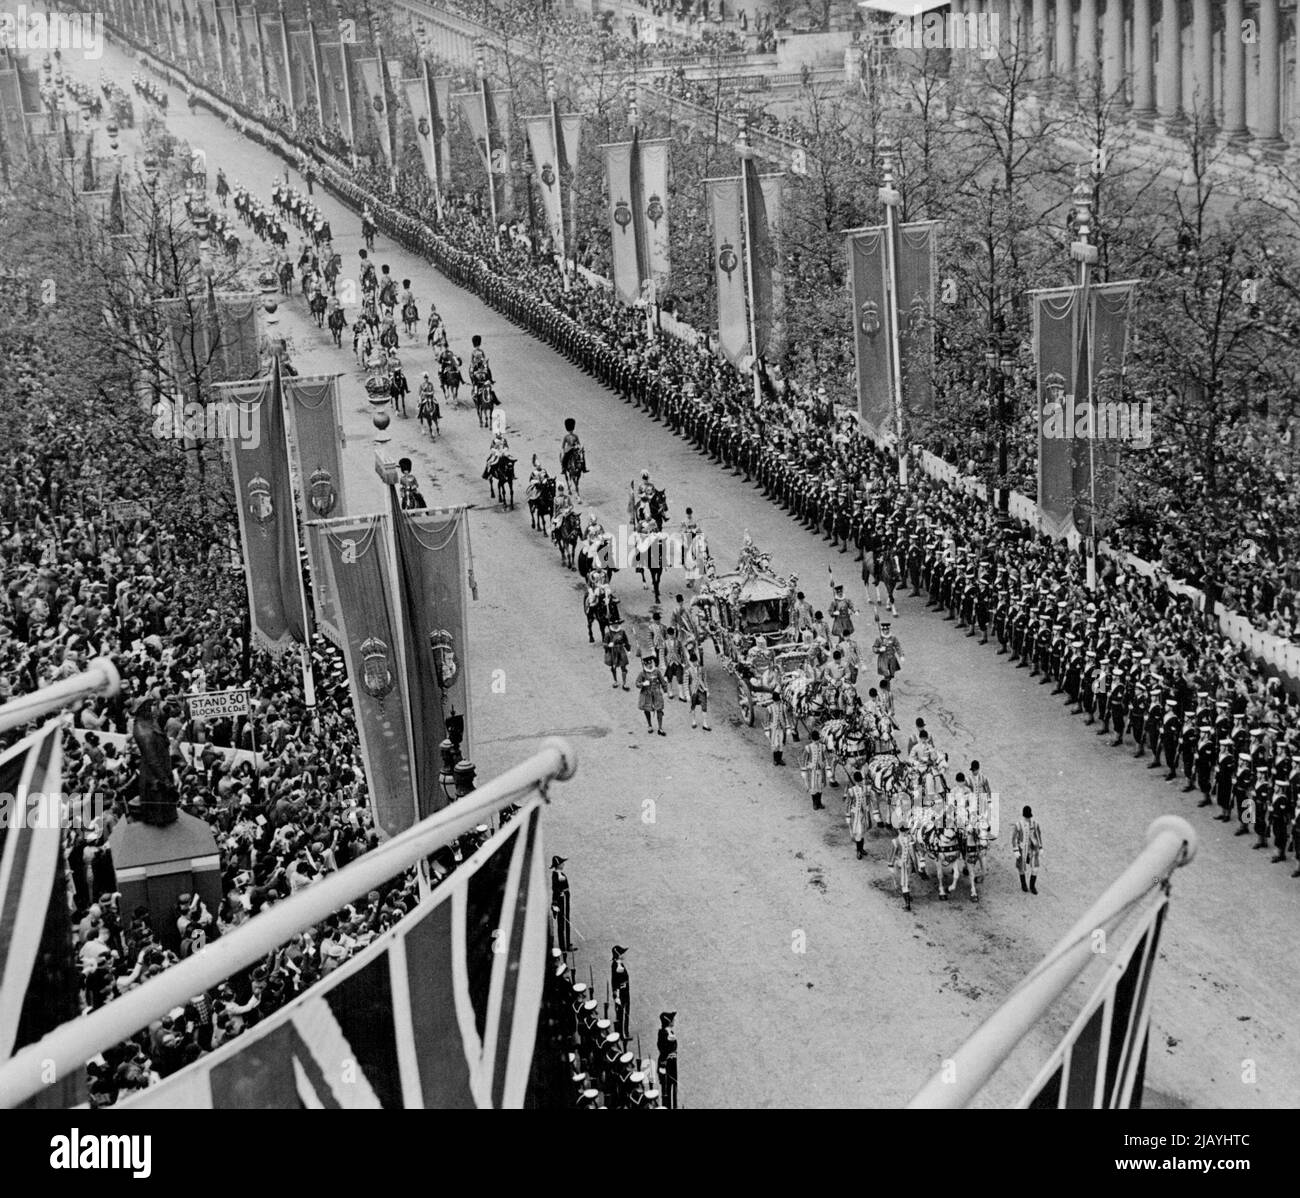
<box><xmin>309</xmin><ymin>516</ymin><xmax>416</xmax><ymax>835</ymax></box>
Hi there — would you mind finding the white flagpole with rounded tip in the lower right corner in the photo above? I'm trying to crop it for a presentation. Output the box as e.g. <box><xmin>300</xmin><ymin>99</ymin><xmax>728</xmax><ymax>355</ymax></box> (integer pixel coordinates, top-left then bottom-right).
<box><xmin>907</xmin><ymin>815</ymin><xmax>1196</xmax><ymax>1111</ymax></box>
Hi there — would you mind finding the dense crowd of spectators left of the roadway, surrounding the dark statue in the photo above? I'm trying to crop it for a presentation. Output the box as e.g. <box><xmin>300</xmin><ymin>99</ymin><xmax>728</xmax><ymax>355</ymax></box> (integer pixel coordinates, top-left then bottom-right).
<box><xmin>0</xmin><ymin>305</ymin><xmax>485</xmax><ymax>1106</ymax></box>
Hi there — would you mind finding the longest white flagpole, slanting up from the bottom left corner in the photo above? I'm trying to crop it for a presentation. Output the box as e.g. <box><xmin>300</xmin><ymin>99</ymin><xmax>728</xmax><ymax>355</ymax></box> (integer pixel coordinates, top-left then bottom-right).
<box><xmin>0</xmin><ymin>738</ymin><xmax>577</xmax><ymax>1108</ymax></box>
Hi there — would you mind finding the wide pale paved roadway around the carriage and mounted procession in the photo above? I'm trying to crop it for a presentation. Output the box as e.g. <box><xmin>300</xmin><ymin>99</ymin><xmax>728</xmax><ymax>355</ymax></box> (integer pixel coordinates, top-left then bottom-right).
<box><xmin>73</xmin><ymin>47</ymin><xmax>1300</xmax><ymax>1107</ymax></box>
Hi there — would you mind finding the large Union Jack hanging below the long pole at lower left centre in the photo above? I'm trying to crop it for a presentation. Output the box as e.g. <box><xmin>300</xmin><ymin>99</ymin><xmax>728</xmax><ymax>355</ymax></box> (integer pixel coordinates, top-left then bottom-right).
<box><xmin>120</xmin><ymin>794</ymin><xmax>550</xmax><ymax>1110</ymax></box>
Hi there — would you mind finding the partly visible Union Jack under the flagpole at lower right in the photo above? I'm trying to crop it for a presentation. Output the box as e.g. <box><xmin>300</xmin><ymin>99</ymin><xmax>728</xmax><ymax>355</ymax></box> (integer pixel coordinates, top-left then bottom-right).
<box><xmin>1017</xmin><ymin>894</ymin><xmax>1169</xmax><ymax>1111</ymax></box>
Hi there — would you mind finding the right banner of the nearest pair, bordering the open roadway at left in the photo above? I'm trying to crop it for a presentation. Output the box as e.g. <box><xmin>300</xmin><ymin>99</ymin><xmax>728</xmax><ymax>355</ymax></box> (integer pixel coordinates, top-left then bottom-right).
<box><xmin>391</xmin><ymin>504</ymin><xmax>472</xmax><ymax>819</ymax></box>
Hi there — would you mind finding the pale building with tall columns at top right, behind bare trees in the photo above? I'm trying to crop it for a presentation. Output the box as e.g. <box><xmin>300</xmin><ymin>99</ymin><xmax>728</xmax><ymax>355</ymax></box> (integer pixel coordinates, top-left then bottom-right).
<box><xmin>953</xmin><ymin>0</ymin><xmax>1300</xmax><ymax>146</ymax></box>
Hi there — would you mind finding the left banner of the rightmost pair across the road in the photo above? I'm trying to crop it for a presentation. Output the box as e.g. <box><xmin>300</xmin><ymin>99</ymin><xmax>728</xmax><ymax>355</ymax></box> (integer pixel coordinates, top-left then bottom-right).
<box><xmin>1030</xmin><ymin>287</ymin><xmax>1082</xmax><ymax>538</ymax></box>
